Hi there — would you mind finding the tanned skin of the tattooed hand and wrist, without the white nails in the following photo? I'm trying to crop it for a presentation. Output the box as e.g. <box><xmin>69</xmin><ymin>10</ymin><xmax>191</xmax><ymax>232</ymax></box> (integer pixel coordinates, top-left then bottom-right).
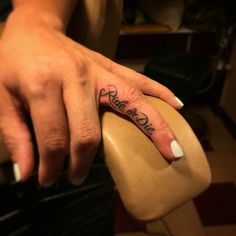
<box><xmin>0</xmin><ymin>0</ymin><xmax>181</xmax><ymax>185</ymax></box>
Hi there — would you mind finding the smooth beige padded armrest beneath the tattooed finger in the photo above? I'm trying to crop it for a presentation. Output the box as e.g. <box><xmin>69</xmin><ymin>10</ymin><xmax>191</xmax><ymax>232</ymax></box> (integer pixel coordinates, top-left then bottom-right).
<box><xmin>102</xmin><ymin>97</ymin><xmax>211</xmax><ymax>221</ymax></box>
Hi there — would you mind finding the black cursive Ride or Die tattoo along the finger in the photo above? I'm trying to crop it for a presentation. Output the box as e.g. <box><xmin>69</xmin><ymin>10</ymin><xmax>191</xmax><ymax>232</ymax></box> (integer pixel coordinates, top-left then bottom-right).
<box><xmin>100</xmin><ymin>85</ymin><xmax>155</xmax><ymax>135</ymax></box>
